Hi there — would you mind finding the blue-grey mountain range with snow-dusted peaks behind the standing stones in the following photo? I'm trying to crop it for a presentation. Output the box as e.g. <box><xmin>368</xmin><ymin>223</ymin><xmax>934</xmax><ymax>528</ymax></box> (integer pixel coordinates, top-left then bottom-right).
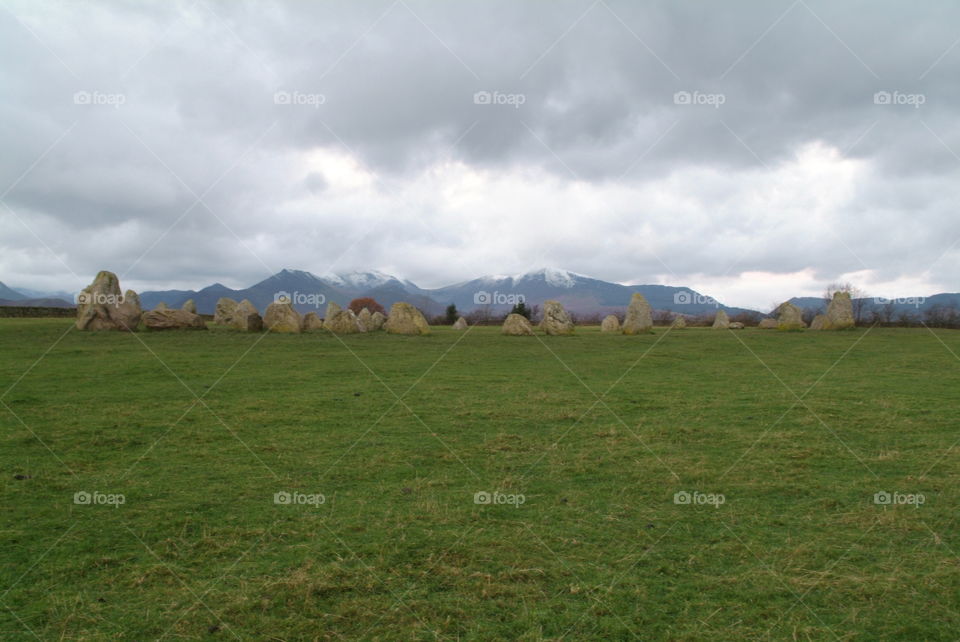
<box><xmin>0</xmin><ymin>268</ymin><xmax>960</xmax><ymax>316</ymax></box>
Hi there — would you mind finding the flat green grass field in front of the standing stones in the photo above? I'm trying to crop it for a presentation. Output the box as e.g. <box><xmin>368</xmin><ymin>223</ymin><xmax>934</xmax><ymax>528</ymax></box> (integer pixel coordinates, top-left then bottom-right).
<box><xmin>0</xmin><ymin>319</ymin><xmax>960</xmax><ymax>640</ymax></box>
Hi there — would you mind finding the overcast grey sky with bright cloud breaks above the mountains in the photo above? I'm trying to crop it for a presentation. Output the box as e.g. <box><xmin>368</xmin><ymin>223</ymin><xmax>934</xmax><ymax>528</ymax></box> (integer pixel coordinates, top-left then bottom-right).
<box><xmin>0</xmin><ymin>0</ymin><xmax>960</xmax><ymax>308</ymax></box>
